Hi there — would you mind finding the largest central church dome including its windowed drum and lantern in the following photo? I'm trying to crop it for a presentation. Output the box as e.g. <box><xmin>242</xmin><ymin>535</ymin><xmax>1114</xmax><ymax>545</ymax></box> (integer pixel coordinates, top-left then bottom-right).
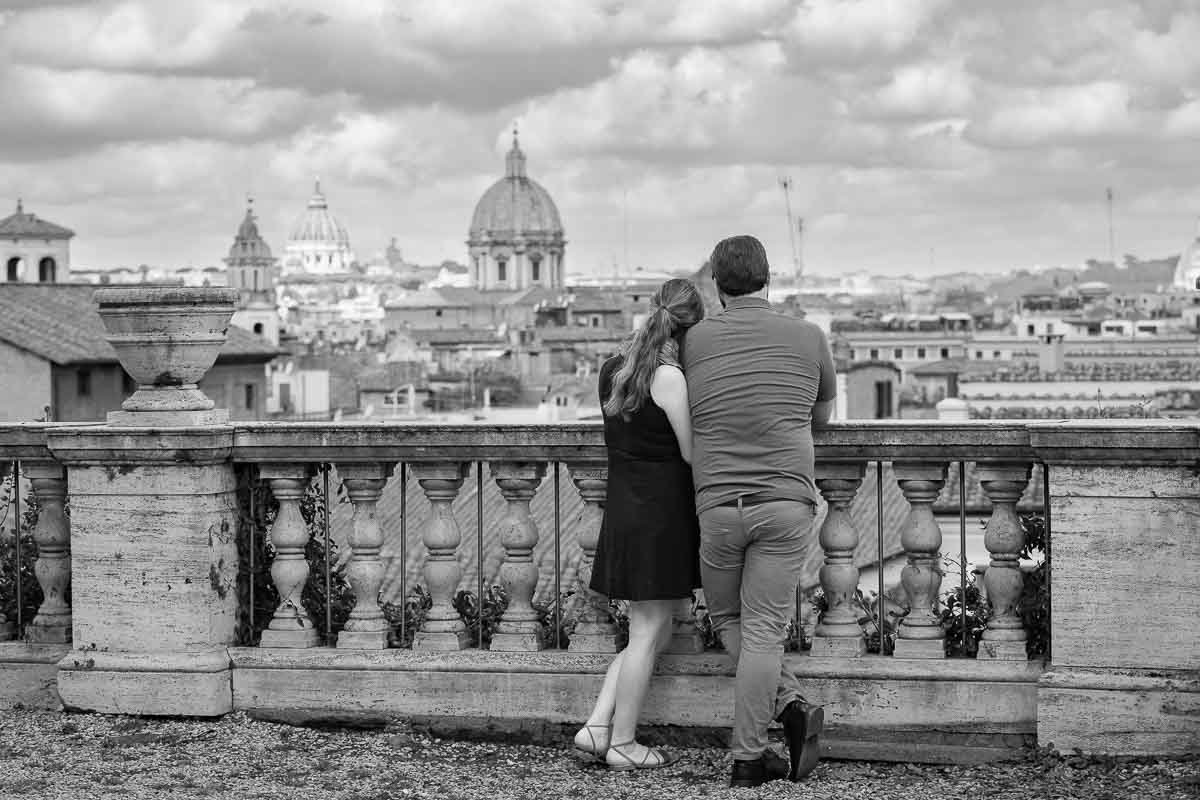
<box><xmin>467</xmin><ymin>131</ymin><xmax>566</xmax><ymax>291</ymax></box>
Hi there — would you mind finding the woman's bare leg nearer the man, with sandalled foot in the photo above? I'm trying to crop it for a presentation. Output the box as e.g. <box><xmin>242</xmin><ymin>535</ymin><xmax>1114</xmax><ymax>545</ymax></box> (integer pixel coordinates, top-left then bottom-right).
<box><xmin>605</xmin><ymin>600</ymin><xmax>677</xmax><ymax>762</ymax></box>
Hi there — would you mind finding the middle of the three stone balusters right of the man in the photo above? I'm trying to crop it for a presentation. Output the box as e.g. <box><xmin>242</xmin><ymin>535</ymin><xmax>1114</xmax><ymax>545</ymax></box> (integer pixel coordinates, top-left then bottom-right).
<box><xmin>892</xmin><ymin>462</ymin><xmax>948</xmax><ymax>658</ymax></box>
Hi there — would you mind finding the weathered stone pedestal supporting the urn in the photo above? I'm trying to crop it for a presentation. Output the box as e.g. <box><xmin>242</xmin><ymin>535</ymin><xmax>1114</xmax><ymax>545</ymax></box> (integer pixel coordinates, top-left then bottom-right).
<box><xmin>48</xmin><ymin>427</ymin><xmax>238</xmax><ymax>716</ymax></box>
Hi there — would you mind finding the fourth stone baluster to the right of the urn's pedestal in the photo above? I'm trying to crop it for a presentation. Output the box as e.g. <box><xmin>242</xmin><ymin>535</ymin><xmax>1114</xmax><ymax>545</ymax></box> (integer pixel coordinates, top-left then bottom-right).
<box><xmin>491</xmin><ymin>461</ymin><xmax>546</xmax><ymax>652</ymax></box>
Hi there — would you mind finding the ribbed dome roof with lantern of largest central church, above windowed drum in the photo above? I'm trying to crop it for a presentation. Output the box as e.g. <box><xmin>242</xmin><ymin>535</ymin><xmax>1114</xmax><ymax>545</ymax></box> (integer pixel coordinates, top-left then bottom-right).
<box><xmin>469</xmin><ymin>133</ymin><xmax>563</xmax><ymax>240</ymax></box>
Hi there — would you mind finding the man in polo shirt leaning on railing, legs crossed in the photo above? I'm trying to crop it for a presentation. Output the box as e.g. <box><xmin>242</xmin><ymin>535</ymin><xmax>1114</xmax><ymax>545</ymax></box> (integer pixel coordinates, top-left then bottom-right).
<box><xmin>682</xmin><ymin>236</ymin><xmax>836</xmax><ymax>787</ymax></box>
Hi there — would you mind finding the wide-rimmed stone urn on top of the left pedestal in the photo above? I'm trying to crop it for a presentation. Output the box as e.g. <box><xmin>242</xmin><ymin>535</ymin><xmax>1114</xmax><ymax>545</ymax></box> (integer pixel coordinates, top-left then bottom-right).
<box><xmin>94</xmin><ymin>287</ymin><xmax>238</xmax><ymax>421</ymax></box>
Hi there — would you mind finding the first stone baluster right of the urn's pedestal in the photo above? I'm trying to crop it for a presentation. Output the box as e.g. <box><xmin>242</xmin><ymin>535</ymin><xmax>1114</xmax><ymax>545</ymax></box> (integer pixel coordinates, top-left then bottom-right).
<box><xmin>259</xmin><ymin>464</ymin><xmax>319</xmax><ymax>648</ymax></box>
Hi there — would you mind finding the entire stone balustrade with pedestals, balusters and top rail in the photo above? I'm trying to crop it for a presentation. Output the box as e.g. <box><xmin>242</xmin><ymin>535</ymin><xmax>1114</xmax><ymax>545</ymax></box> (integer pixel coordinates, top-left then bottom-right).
<box><xmin>0</xmin><ymin>421</ymin><xmax>1200</xmax><ymax>752</ymax></box>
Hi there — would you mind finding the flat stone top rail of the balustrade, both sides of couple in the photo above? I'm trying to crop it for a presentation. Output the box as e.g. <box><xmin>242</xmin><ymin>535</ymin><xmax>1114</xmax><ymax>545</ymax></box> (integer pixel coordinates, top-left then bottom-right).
<box><xmin>0</xmin><ymin>420</ymin><xmax>1200</xmax><ymax>465</ymax></box>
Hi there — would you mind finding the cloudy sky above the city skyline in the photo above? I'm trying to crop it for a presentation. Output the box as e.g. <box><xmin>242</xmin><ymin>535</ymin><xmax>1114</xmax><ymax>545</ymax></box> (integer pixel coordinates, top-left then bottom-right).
<box><xmin>0</xmin><ymin>0</ymin><xmax>1200</xmax><ymax>273</ymax></box>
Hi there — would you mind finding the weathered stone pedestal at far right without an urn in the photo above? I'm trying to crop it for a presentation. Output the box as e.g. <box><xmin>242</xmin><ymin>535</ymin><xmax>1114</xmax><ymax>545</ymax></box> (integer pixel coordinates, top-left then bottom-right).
<box><xmin>1027</xmin><ymin>420</ymin><xmax>1200</xmax><ymax>756</ymax></box>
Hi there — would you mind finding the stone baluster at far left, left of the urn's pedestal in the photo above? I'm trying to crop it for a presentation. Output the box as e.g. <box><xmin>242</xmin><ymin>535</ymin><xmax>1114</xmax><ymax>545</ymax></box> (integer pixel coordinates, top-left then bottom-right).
<box><xmin>18</xmin><ymin>462</ymin><xmax>71</xmax><ymax>644</ymax></box>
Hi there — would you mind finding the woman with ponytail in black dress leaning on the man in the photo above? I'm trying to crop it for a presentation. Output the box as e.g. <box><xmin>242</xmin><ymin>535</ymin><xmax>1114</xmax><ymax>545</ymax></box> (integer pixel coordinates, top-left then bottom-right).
<box><xmin>575</xmin><ymin>278</ymin><xmax>704</xmax><ymax>770</ymax></box>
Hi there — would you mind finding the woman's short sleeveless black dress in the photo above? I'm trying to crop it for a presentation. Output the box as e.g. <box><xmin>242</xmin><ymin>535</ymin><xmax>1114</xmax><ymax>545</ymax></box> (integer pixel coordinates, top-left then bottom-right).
<box><xmin>590</xmin><ymin>356</ymin><xmax>700</xmax><ymax>600</ymax></box>
